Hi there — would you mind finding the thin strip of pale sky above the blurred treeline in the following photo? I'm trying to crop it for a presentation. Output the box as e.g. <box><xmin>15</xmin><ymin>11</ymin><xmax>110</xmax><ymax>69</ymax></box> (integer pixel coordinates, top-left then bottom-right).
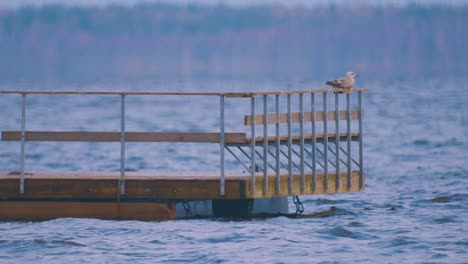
<box><xmin>0</xmin><ymin>0</ymin><xmax>468</xmax><ymax>7</ymax></box>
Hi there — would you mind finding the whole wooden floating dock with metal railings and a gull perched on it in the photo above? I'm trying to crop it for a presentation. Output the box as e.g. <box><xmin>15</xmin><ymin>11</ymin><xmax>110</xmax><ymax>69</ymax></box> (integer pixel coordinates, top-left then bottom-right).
<box><xmin>0</xmin><ymin>89</ymin><xmax>367</xmax><ymax>221</ymax></box>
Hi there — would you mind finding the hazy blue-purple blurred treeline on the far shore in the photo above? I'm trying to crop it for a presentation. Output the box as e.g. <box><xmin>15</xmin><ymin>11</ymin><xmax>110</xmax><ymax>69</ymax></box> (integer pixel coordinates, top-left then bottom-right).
<box><xmin>0</xmin><ymin>4</ymin><xmax>468</xmax><ymax>83</ymax></box>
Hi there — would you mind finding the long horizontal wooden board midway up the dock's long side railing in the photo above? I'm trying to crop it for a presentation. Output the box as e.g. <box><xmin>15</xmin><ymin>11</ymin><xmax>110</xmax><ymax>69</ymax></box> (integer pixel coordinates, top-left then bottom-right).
<box><xmin>2</xmin><ymin>131</ymin><xmax>245</xmax><ymax>143</ymax></box>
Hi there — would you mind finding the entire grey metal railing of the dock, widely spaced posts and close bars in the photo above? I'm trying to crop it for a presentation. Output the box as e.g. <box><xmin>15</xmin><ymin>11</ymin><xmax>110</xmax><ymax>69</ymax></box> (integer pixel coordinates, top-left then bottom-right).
<box><xmin>1</xmin><ymin>89</ymin><xmax>367</xmax><ymax>196</ymax></box>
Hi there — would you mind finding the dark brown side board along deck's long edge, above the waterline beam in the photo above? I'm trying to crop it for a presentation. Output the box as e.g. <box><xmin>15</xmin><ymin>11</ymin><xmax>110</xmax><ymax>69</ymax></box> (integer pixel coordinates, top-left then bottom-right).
<box><xmin>0</xmin><ymin>174</ymin><xmax>246</xmax><ymax>201</ymax></box>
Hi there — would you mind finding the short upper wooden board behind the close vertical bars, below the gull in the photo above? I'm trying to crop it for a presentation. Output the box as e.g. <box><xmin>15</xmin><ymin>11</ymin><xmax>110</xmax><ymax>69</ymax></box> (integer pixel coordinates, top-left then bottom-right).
<box><xmin>244</xmin><ymin>110</ymin><xmax>359</xmax><ymax>126</ymax></box>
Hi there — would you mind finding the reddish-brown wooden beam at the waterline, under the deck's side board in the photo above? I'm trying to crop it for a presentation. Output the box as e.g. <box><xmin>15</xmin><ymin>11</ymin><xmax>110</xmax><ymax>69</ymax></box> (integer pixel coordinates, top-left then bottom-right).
<box><xmin>0</xmin><ymin>201</ymin><xmax>176</xmax><ymax>221</ymax></box>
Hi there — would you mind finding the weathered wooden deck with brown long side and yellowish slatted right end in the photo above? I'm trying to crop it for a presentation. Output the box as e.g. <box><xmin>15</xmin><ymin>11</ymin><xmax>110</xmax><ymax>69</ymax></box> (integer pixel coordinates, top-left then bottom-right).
<box><xmin>0</xmin><ymin>172</ymin><xmax>361</xmax><ymax>202</ymax></box>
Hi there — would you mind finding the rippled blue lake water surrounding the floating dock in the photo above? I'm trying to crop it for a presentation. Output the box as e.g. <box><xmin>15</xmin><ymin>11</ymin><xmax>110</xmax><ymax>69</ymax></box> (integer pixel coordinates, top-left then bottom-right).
<box><xmin>0</xmin><ymin>80</ymin><xmax>468</xmax><ymax>263</ymax></box>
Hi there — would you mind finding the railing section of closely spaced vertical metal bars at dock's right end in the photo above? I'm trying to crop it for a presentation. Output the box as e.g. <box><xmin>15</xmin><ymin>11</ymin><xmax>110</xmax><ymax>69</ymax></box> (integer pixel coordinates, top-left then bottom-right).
<box><xmin>222</xmin><ymin>89</ymin><xmax>367</xmax><ymax>195</ymax></box>
